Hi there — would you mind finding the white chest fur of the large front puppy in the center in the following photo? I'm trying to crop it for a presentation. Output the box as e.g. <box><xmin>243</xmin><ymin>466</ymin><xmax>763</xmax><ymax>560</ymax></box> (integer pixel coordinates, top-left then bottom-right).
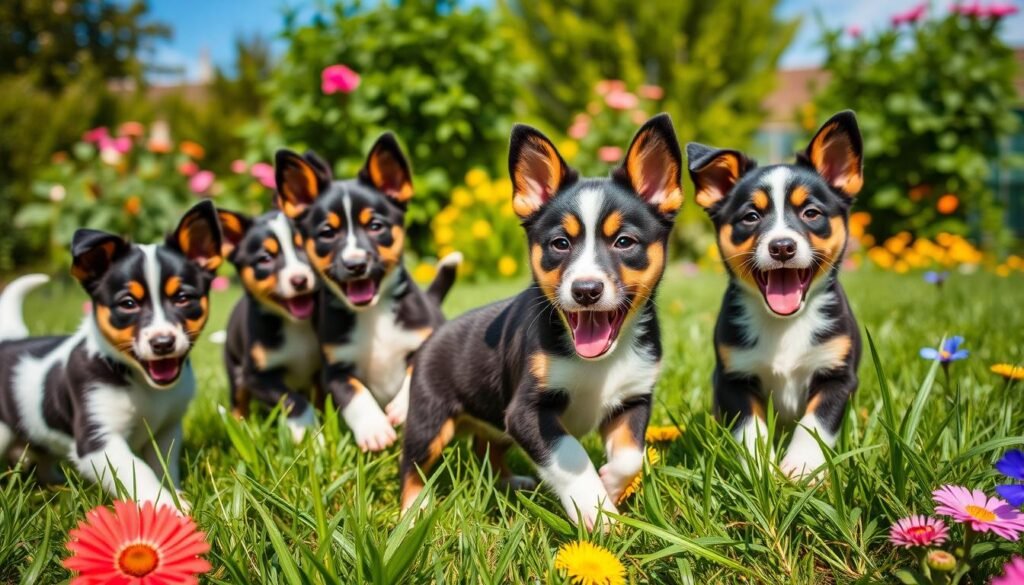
<box><xmin>548</xmin><ymin>327</ymin><xmax>660</xmax><ymax>436</ymax></box>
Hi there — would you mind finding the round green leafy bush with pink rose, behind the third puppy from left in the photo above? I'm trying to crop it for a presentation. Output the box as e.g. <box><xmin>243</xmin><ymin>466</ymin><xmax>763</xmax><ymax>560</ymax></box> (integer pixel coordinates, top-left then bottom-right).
<box><xmin>264</xmin><ymin>0</ymin><xmax>521</xmax><ymax>242</ymax></box>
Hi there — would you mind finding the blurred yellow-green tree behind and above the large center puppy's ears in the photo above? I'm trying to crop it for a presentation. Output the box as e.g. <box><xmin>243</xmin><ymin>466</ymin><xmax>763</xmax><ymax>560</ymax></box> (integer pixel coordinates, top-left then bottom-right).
<box><xmin>503</xmin><ymin>0</ymin><xmax>797</xmax><ymax>148</ymax></box>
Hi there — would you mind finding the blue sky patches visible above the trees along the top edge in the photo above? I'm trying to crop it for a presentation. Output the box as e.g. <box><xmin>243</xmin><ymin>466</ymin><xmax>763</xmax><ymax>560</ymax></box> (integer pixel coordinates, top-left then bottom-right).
<box><xmin>151</xmin><ymin>0</ymin><xmax>1024</xmax><ymax>81</ymax></box>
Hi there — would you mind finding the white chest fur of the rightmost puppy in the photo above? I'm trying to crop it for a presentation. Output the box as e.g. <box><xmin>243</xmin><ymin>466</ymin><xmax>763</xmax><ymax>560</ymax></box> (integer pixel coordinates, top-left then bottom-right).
<box><xmin>724</xmin><ymin>293</ymin><xmax>845</xmax><ymax>421</ymax></box>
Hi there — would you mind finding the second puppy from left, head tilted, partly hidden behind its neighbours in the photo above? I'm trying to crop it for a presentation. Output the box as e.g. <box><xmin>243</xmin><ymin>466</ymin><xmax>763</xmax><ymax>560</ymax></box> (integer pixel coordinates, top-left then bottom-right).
<box><xmin>217</xmin><ymin>209</ymin><xmax>321</xmax><ymax>441</ymax></box>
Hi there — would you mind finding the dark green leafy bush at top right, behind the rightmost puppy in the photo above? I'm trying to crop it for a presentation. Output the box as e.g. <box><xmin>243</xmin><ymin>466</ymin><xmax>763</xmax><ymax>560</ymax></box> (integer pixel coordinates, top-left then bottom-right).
<box><xmin>817</xmin><ymin>9</ymin><xmax>1017</xmax><ymax>245</ymax></box>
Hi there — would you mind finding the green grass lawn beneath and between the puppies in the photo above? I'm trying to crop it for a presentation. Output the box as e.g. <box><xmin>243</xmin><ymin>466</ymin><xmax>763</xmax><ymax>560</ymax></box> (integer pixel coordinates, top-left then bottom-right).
<box><xmin>0</xmin><ymin>267</ymin><xmax>1024</xmax><ymax>584</ymax></box>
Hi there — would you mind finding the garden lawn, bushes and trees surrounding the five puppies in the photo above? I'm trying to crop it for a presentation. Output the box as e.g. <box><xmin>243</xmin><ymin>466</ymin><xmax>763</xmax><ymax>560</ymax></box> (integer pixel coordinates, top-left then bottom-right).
<box><xmin>0</xmin><ymin>0</ymin><xmax>1024</xmax><ymax>583</ymax></box>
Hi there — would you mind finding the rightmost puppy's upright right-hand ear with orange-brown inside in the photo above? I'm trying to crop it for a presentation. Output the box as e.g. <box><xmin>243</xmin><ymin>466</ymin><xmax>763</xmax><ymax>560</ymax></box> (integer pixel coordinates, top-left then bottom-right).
<box><xmin>799</xmin><ymin>110</ymin><xmax>864</xmax><ymax>198</ymax></box>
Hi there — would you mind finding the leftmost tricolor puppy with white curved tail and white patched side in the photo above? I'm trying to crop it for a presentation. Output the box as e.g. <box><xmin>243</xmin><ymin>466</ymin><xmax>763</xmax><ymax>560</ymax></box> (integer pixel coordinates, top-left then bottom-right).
<box><xmin>0</xmin><ymin>201</ymin><xmax>221</xmax><ymax>502</ymax></box>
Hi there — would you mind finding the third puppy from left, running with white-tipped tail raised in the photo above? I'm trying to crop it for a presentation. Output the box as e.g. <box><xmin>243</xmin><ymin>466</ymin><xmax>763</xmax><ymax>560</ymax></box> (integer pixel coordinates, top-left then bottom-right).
<box><xmin>276</xmin><ymin>133</ymin><xmax>460</xmax><ymax>451</ymax></box>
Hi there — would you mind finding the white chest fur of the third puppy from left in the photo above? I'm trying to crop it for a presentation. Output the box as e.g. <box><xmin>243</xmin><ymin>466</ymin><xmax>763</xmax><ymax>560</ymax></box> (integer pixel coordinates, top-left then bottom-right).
<box><xmin>327</xmin><ymin>299</ymin><xmax>430</xmax><ymax>405</ymax></box>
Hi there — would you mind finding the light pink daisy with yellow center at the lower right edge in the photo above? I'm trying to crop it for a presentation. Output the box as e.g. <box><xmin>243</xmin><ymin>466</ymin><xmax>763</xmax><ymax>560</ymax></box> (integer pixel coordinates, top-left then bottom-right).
<box><xmin>932</xmin><ymin>486</ymin><xmax>1024</xmax><ymax>540</ymax></box>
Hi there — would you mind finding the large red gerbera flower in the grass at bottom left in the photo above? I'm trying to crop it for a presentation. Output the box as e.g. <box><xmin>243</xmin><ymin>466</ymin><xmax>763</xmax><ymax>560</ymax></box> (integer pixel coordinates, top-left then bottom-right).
<box><xmin>65</xmin><ymin>501</ymin><xmax>210</xmax><ymax>585</ymax></box>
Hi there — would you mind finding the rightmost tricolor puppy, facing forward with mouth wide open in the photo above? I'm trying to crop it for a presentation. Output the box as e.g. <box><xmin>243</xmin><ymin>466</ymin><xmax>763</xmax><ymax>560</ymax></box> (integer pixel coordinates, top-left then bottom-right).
<box><xmin>686</xmin><ymin>112</ymin><xmax>862</xmax><ymax>477</ymax></box>
